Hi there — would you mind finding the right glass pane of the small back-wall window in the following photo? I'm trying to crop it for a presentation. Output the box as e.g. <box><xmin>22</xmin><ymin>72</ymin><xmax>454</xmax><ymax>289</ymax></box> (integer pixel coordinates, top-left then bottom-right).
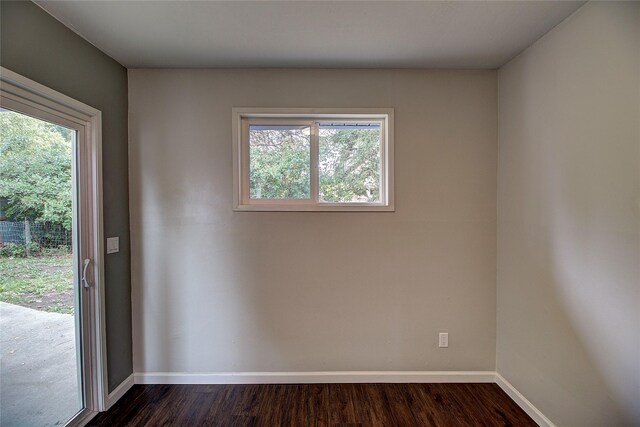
<box><xmin>318</xmin><ymin>122</ymin><xmax>381</xmax><ymax>203</ymax></box>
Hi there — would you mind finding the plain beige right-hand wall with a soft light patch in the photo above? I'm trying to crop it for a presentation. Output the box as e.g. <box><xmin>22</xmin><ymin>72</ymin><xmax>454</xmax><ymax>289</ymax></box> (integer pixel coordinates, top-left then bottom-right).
<box><xmin>497</xmin><ymin>3</ymin><xmax>640</xmax><ymax>427</ymax></box>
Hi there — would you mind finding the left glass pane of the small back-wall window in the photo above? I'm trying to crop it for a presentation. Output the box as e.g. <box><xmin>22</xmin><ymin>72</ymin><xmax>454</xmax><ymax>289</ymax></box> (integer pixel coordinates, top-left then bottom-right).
<box><xmin>249</xmin><ymin>125</ymin><xmax>311</xmax><ymax>199</ymax></box>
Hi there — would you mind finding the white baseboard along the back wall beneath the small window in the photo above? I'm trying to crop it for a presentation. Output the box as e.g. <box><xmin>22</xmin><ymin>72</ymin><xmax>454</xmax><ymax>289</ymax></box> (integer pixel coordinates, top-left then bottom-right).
<box><xmin>134</xmin><ymin>371</ymin><xmax>495</xmax><ymax>384</ymax></box>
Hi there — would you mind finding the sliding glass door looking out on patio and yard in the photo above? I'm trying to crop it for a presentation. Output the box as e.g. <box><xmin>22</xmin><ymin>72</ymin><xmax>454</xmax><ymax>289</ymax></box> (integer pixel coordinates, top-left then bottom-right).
<box><xmin>0</xmin><ymin>104</ymin><xmax>92</xmax><ymax>427</ymax></box>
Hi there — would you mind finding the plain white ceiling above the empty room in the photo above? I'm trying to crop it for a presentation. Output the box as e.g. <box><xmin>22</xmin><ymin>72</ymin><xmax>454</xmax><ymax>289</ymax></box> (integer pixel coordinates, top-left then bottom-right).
<box><xmin>37</xmin><ymin>0</ymin><xmax>584</xmax><ymax>68</ymax></box>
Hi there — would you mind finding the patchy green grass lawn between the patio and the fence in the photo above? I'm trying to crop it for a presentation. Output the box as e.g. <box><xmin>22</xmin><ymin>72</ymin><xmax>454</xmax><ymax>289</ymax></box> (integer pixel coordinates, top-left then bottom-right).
<box><xmin>0</xmin><ymin>254</ymin><xmax>74</xmax><ymax>314</ymax></box>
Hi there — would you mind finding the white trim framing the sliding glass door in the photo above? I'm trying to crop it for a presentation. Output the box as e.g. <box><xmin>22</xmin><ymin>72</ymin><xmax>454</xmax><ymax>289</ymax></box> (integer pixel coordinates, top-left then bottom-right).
<box><xmin>0</xmin><ymin>67</ymin><xmax>108</xmax><ymax>418</ymax></box>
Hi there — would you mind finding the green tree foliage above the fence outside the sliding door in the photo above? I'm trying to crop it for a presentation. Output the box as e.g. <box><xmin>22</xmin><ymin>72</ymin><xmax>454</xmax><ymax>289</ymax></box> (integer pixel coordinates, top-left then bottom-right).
<box><xmin>0</xmin><ymin>110</ymin><xmax>73</xmax><ymax>230</ymax></box>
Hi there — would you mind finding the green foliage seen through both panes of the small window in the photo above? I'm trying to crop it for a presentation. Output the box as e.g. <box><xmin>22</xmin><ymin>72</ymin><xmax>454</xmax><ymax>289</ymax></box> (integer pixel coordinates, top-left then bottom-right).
<box><xmin>249</xmin><ymin>126</ymin><xmax>380</xmax><ymax>203</ymax></box>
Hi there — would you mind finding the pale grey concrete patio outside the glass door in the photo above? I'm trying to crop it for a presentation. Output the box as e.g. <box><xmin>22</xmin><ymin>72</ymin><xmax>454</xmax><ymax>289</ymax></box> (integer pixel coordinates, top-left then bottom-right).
<box><xmin>0</xmin><ymin>302</ymin><xmax>80</xmax><ymax>427</ymax></box>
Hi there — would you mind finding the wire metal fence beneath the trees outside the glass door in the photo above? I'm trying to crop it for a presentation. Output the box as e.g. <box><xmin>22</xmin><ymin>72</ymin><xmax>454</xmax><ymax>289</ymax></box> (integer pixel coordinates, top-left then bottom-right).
<box><xmin>0</xmin><ymin>221</ymin><xmax>71</xmax><ymax>249</ymax></box>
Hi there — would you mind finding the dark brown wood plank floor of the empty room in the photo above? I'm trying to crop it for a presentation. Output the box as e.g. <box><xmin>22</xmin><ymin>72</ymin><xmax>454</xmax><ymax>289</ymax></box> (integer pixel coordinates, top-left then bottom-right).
<box><xmin>89</xmin><ymin>384</ymin><xmax>536</xmax><ymax>427</ymax></box>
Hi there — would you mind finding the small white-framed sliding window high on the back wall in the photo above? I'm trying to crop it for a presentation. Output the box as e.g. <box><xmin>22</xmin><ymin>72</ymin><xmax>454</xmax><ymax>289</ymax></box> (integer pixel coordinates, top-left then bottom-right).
<box><xmin>233</xmin><ymin>108</ymin><xmax>394</xmax><ymax>211</ymax></box>
